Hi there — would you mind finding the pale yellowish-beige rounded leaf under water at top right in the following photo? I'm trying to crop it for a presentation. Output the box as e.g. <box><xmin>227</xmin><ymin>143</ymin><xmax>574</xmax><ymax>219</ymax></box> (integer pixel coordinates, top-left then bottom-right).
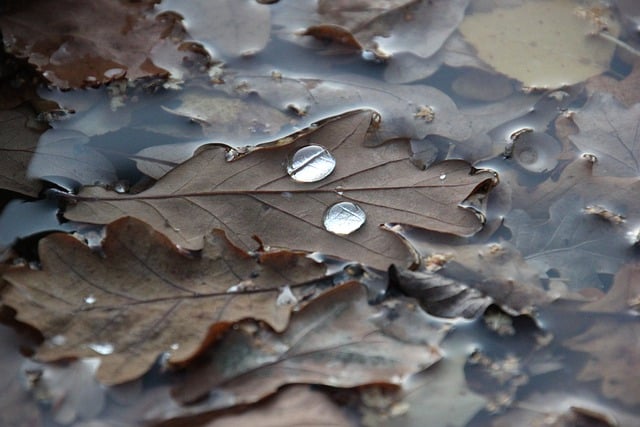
<box><xmin>460</xmin><ymin>0</ymin><xmax>618</xmax><ymax>88</ymax></box>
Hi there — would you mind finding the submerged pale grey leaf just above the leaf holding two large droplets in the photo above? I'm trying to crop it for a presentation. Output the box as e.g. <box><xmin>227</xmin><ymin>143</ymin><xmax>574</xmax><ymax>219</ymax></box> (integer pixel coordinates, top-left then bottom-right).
<box><xmin>231</xmin><ymin>75</ymin><xmax>471</xmax><ymax>145</ymax></box>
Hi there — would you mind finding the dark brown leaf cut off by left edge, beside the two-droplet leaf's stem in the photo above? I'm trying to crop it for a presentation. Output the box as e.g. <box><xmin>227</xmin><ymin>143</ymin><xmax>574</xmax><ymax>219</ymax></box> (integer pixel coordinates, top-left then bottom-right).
<box><xmin>0</xmin><ymin>110</ymin><xmax>41</xmax><ymax>196</ymax></box>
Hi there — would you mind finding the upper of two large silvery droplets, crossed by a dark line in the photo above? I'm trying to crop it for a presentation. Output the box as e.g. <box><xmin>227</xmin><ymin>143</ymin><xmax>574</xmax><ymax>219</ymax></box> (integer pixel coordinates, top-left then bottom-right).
<box><xmin>287</xmin><ymin>145</ymin><xmax>336</xmax><ymax>182</ymax></box>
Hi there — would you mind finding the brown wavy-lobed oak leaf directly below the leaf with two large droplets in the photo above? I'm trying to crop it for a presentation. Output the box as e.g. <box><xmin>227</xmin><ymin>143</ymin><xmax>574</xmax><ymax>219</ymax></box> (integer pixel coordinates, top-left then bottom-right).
<box><xmin>2</xmin><ymin>218</ymin><xmax>323</xmax><ymax>384</ymax></box>
